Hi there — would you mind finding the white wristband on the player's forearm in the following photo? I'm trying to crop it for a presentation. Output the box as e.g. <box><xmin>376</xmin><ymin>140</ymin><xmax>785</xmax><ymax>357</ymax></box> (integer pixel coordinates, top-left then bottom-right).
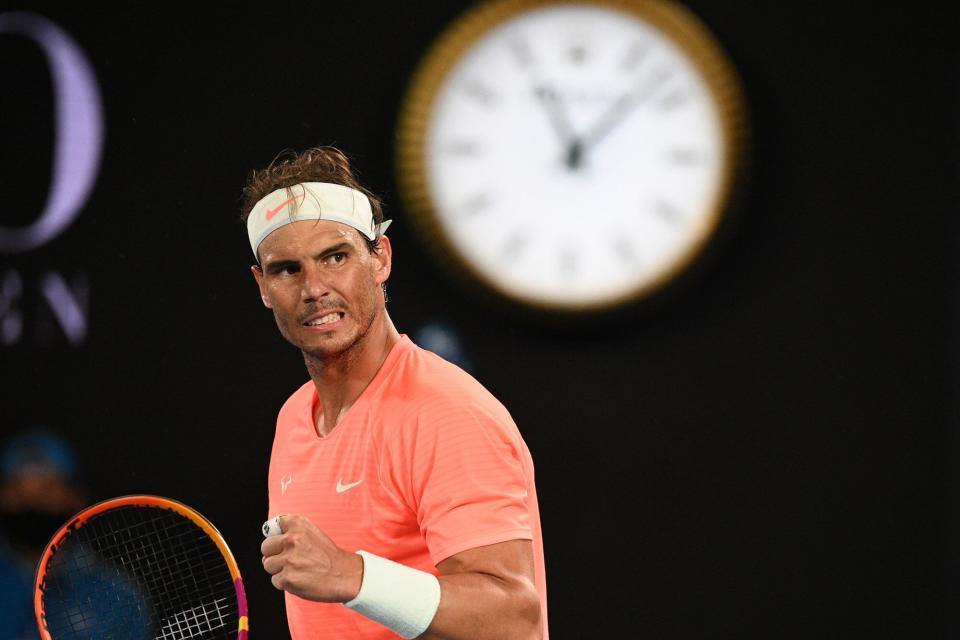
<box><xmin>343</xmin><ymin>551</ymin><xmax>440</xmax><ymax>638</ymax></box>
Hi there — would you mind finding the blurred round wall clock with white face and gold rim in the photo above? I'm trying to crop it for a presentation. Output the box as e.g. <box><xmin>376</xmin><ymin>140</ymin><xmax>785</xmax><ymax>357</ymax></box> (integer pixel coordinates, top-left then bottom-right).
<box><xmin>397</xmin><ymin>0</ymin><xmax>746</xmax><ymax>314</ymax></box>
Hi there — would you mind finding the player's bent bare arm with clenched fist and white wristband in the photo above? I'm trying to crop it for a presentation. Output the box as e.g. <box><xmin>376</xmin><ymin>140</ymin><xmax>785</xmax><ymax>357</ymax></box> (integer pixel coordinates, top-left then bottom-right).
<box><xmin>261</xmin><ymin>515</ymin><xmax>543</xmax><ymax>640</ymax></box>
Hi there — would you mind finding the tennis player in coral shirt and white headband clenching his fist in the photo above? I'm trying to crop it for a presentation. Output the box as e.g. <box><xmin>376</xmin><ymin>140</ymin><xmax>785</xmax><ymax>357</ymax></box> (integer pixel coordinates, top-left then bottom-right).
<box><xmin>243</xmin><ymin>147</ymin><xmax>548</xmax><ymax>640</ymax></box>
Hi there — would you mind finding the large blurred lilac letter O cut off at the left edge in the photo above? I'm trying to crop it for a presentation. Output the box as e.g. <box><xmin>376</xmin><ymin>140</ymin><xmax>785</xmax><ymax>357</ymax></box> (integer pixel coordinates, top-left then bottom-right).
<box><xmin>0</xmin><ymin>12</ymin><xmax>103</xmax><ymax>253</ymax></box>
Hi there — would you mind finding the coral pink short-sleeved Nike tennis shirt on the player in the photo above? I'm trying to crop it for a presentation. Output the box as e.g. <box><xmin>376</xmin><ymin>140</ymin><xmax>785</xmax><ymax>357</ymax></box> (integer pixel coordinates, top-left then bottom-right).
<box><xmin>268</xmin><ymin>335</ymin><xmax>548</xmax><ymax>640</ymax></box>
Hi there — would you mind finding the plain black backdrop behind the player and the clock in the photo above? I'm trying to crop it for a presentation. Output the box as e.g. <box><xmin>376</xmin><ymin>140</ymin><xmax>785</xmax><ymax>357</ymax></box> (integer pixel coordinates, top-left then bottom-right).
<box><xmin>0</xmin><ymin>0</ymin><xmax>960</xmax><ymax>639</ymax></box>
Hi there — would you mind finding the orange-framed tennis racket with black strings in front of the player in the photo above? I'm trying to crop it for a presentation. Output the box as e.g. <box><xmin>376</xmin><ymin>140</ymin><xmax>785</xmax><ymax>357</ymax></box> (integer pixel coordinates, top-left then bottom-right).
<box><xmin>34</xmin><ymin>495</ymin><xmax>249</xmax><ymax>640</ymax></box>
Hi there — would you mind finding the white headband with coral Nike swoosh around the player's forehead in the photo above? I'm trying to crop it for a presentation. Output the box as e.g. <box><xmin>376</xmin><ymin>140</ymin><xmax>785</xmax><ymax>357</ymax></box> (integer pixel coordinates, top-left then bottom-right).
<box><xmin>247</xmin><ymin>182</ymin><xmax>391</xmax><ymax>261</ymax></box>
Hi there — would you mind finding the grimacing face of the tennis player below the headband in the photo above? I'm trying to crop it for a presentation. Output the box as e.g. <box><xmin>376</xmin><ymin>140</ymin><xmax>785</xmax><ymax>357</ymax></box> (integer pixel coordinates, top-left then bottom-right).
<box><xmin>253</xmin><ymin>220</ymin><xmax>391</xmax><ymax>359</ymax></box>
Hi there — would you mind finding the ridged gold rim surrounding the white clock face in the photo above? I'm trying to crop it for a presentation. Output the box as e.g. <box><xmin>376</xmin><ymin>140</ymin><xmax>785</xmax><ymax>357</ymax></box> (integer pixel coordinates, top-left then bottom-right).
<box><xmin>395</xmin><ymin>0</ymin><xmax>747</xmax><ymax>315</ymax></box>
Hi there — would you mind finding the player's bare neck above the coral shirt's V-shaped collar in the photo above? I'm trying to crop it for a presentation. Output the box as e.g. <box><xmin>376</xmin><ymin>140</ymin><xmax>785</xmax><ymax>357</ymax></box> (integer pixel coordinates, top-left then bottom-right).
<box><xmin>303</xmin><ymin>310</ymin><xmax>400</xmax><ymax>436</ymax></box>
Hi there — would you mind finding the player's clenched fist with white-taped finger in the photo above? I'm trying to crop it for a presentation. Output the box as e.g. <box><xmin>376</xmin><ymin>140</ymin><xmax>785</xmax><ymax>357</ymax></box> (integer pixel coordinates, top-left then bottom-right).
<box><xmin>260</xmin><ymin>515</ymin><xmax>363</xmax><ymax>602</ymax></box>
